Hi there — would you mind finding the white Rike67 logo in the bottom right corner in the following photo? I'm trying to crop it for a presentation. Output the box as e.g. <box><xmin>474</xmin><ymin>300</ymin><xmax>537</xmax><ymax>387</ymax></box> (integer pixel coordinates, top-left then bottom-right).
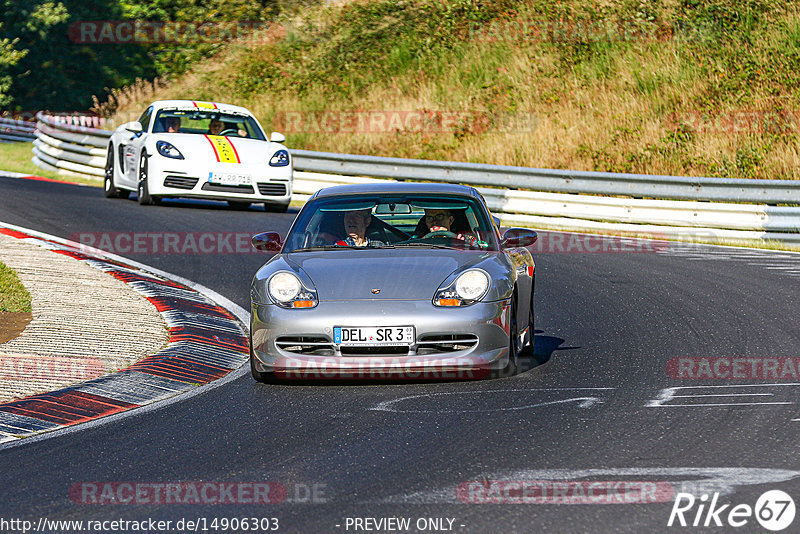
<box><xmin>667</xmin><ymin>490</ymin><xmax>795</xmax><ymax>532</ymax></box>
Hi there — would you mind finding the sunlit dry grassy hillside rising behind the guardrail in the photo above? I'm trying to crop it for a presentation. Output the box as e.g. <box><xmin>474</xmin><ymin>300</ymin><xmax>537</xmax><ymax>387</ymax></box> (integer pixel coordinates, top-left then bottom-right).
<box><xmin>97</xmin><ymin>0</ymin><xmax>800</xmax><ymax>179</ymax></box>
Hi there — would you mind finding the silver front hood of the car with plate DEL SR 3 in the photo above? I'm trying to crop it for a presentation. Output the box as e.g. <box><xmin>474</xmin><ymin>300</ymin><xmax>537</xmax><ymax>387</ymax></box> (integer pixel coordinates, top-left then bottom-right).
<box><xmin>284</xmin><ymin>248</ymin><xmax>486</xmax><ymax>301</ymax></box>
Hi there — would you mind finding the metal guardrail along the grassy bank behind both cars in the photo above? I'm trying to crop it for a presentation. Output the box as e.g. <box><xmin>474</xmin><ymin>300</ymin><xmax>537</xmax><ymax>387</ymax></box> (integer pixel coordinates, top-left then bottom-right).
<box><xmin>28</xmin><ymin>113</ymin><xmax>800</xmax><ymax>243</ymax></box>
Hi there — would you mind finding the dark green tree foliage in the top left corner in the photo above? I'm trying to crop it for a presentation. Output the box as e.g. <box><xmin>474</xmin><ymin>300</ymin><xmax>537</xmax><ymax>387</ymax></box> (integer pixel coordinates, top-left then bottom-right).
<box><xmin>0</xmin><ymin>0</ymin><xmax>298</xmax><ymax>111</ymax></box>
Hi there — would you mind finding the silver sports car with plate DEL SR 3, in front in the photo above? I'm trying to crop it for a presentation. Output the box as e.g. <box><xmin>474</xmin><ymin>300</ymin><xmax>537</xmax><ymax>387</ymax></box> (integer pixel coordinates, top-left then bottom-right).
<box><xmin>250</xmin><ymin>183</ymin><xmax>537</xmax><ymax>382</ymax></box>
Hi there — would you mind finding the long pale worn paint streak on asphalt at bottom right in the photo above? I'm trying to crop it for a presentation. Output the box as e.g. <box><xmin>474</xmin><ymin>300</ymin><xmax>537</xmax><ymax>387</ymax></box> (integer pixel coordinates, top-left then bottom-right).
<box><xmin>376</xmin><ymin>467</ymin><xmax>800</xmax><ymax>504</ymax></box>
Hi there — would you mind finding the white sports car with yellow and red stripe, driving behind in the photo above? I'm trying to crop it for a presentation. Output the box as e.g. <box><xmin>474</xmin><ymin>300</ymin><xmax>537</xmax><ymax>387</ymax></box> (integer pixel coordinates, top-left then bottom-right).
<box><xmin>105</xmin><ymin>100</ymin><xmax>292</xmax><ymax>211</ymax></box>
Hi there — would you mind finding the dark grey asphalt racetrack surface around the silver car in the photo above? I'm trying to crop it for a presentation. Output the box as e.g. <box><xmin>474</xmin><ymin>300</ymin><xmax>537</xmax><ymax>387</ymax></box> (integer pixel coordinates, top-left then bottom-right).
<box><xmin>0</xmin><ymin>174</ymin><xmax>800</xmax><ymax>532</ymax></box>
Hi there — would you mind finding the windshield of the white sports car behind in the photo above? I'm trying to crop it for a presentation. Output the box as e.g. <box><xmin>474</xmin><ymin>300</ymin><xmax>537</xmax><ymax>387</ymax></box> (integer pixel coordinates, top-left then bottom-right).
<box><xmin>153</xmin><ymin>109</ymin><xmax>266</xmax><ymax>141</ymax></box>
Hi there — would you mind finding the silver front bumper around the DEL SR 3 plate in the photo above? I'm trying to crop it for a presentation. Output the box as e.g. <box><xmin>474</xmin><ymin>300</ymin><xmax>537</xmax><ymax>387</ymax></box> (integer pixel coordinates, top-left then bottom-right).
<box><xmin>250</xmin><ymin>300</ymin><xmax>510</xmax><ymax>379</ymax></box>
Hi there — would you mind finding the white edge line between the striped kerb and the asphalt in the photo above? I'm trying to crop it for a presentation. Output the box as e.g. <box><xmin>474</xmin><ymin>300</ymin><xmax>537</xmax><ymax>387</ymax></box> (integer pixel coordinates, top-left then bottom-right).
<box><xmin>0</xmin><ymin>221</ymin><xmax>250</xmax><ymax>450</ymax></box>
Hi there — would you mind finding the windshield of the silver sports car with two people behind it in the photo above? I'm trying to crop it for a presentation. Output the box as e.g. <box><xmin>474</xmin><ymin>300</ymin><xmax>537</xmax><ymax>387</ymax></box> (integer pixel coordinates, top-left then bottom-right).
<box><xmin>283</xmin><ymin>194</ymin><xmax>498</xmax><ymax>252</ymax></box>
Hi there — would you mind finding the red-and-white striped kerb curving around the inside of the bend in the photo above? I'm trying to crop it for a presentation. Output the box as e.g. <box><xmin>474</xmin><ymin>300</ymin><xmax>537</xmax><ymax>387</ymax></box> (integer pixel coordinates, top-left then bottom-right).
<box><xmin>0</xmin><ymin>224</ymin><xmax>249</xmax><ymax>445</ymax></box>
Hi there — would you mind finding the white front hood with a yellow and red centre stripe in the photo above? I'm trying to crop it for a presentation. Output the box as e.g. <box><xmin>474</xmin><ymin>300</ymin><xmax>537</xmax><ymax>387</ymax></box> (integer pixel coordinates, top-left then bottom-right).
<box><xmin>152</xmin><ymin>133</ymin><xmax>286</xmax><ymax>166</ymax></box>
